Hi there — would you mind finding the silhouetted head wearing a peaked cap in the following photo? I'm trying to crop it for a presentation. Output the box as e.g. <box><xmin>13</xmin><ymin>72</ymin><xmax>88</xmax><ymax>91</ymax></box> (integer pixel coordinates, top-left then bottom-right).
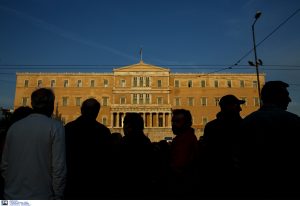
<box><xmin>219</xmin><ymin>94</ymin><xmax>245</xmax><ymax>115</ymax></box>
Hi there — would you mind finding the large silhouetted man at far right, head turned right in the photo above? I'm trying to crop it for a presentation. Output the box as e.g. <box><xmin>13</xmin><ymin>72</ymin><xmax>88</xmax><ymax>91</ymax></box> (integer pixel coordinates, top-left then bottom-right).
<box><xmin>241</xmin><ymin>81</ymin><xmax>300</xmax><ymax>199</ymax></box>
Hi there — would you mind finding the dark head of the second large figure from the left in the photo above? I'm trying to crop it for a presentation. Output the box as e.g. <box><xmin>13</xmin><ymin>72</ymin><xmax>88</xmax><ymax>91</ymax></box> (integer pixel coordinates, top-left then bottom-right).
<box><xmin>81</xmin><ymin>98</ymin><xmax>100</xmax><ymax>120</ymax></box>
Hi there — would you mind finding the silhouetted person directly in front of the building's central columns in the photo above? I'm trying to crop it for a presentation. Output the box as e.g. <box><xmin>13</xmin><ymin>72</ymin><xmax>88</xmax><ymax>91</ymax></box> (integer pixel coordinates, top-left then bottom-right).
<box><xmin>121</xmin><ymin>113</ymin><xmax>153</xmax><ymax>199</ymax></box>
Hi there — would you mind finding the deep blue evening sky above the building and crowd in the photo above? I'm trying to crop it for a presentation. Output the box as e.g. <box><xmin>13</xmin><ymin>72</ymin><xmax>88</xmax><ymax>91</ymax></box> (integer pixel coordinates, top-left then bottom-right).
<box><xmin>0</xmin><ymin>0</ymin><xmax>300</xmax><ymax>115</ymax></box>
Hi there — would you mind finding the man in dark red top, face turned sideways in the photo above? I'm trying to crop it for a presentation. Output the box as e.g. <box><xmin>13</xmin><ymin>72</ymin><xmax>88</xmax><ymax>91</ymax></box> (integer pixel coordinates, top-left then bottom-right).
<box><xmin>170</xmin><ymin>109</ymin><xmax>198</xmax><ymax>195</ymax></box>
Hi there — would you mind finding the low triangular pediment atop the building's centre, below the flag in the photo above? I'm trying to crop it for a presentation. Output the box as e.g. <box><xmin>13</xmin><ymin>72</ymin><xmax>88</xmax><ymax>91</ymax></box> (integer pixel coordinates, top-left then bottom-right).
<box><xmin>113</xmin><ymin>61</ymin><xmax>170</xmax><ymax>73</ymax></box>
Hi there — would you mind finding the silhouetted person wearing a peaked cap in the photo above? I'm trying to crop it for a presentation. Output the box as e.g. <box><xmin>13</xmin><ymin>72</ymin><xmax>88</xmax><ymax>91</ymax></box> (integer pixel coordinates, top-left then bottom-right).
<box><xmin>199</xmin><ymin>94</ymin><xmax>245</xmax><ymax>192</ymax></box>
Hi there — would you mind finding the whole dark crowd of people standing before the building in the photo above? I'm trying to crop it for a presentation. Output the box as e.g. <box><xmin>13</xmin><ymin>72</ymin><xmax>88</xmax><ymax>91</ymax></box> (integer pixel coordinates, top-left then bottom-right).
<box><xmin>0</xmin><ymin>81</ymin><xmax>300</xmax><ymax>200</ymax></box>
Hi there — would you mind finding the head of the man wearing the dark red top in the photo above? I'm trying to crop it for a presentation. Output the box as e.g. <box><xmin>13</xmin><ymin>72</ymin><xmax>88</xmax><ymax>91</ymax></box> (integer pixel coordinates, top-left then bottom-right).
<box><xmin>172</xmin><ymin>109</ymin><xmax>193</xmax><ymax>135</ymax></box>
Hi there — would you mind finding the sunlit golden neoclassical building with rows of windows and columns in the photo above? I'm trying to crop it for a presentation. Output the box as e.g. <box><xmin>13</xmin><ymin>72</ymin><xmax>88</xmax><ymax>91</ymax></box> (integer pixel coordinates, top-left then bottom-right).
<box><xmin>14</xmin><ymin>61</ymin><xmax>265</xmax><ymax>141</ymax></box>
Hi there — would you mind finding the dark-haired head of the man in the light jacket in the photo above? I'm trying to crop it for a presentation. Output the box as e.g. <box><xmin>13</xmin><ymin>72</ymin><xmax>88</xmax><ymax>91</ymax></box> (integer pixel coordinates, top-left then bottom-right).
<box><xmin>31</xmin><ymin>88</ymin><xmax>55</xmax><ymax>117</ymax></box>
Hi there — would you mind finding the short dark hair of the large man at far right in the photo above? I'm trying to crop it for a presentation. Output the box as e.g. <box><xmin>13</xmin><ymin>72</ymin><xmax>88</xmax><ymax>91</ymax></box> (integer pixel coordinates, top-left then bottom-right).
<box><xmin>261</xmin><ymin>81</ymin><xmax>289</xmax><ymax>102</ymax></box>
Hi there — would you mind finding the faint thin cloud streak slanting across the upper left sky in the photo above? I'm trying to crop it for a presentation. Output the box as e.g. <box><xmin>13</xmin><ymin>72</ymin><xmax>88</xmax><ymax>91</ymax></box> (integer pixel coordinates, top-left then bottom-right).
<box><xmin>0</xmin><ymin>6</ymin><xmax>136</xmax><ymax>60</ymax></box>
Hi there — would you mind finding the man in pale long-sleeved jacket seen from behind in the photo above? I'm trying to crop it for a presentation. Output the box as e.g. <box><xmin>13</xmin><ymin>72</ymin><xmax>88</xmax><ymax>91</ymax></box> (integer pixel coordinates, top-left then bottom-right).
<box><xmin>1</xmin><ymin>88</ymin><xmax>66</xmax><ymax>200</ymax></box>
